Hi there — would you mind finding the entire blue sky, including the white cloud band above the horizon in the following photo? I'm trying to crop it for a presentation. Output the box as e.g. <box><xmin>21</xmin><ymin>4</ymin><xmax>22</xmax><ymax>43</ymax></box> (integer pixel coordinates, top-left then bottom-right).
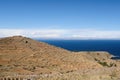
<box><xmin>0</xmin><ymin>0</ymin><xmax>120</xmax><ymax>39</ymax></box>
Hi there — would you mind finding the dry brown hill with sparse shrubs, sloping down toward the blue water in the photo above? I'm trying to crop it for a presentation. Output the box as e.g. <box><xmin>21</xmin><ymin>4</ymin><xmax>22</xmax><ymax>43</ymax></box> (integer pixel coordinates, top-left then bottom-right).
<box><xmin>0</xmin><ymin>36</ymin><xmax>120</xmax><ymax>80</ymax></box>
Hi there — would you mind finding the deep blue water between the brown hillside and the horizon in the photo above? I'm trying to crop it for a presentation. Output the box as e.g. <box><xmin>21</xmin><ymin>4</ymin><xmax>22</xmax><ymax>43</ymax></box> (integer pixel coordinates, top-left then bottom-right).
<box><xmin>38</xmin><ymin>40</ymin><xmax>120</xmax><ymax>56</ymax></box>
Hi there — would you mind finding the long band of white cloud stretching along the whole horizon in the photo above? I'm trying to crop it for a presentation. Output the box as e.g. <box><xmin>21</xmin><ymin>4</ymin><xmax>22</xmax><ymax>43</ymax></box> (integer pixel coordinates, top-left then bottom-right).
<box><xmin>0</xmin><ymin>29</ymin><xmax>120</xmax><ymax>39</ymax></box>
